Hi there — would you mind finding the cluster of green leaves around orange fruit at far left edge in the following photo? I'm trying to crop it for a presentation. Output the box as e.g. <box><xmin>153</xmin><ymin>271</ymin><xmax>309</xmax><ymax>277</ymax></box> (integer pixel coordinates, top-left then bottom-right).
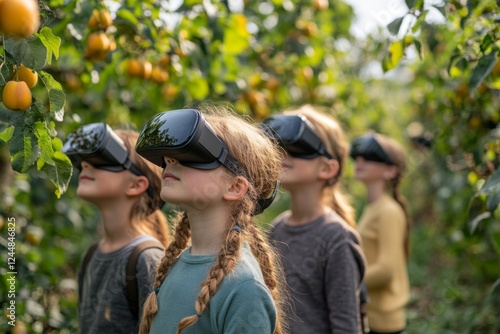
<box><xmin>0</xmin><ymin>27</ymin><xmax>72</xmax><ymax>196</ymax></box>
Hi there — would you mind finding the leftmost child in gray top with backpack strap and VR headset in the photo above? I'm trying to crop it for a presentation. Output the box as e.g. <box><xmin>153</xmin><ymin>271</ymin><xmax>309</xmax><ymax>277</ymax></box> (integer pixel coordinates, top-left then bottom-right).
<box><xmin>63</xmin><ymin>123</ymin><xmax>170</xmax><ymax>334</ymax></box>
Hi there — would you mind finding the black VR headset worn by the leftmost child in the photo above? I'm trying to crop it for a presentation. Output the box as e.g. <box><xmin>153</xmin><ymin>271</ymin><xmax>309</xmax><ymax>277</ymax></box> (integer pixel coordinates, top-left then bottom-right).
<box><xmin>62</xmin><ymin>123</ymin><xmax>155</xmax><ymax>198</ymax></box>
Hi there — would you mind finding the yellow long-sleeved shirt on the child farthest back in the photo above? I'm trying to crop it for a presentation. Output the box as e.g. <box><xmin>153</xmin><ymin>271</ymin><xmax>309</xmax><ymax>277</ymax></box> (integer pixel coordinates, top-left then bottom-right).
<box><xmin>358</xmin><ymin>195</ymin><xmax>410</xmax><ymax>332</ymax></box>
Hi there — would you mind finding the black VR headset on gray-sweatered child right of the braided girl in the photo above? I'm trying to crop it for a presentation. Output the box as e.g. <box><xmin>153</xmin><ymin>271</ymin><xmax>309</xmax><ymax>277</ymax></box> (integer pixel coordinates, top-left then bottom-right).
<box><xmin>262</xmin><ymin>115</ymin><xmax>333</xmax><ymax>159</ymax></box>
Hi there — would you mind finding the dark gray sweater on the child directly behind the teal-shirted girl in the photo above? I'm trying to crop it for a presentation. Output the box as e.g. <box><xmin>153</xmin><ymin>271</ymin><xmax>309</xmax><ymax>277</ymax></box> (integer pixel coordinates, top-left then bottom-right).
<box><xmin>270</xmin><ymin>211</ymin><xmax>365</xmax><ymax>334</ymax></box>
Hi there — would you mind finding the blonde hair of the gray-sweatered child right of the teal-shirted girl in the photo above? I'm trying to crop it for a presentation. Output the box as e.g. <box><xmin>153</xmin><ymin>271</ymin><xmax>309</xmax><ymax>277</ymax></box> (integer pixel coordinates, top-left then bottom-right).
<box><xmin>283</xmin><ymin>104</ymin><xmax>356</xmax><ymax>227</ymax></box>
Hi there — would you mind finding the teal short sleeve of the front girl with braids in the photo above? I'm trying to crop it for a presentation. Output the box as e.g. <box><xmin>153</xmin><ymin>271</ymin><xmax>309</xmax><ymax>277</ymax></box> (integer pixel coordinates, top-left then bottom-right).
<box><xmin>217</xmin><ymin>280</ymin><xmax>276</xmax><ymax>334</ymax></box>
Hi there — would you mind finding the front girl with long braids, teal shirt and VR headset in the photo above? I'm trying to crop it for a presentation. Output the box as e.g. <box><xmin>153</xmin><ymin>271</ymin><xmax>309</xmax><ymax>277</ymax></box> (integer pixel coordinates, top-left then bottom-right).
<box><xmin>136</xmin><ymin>107</ymin><xmax>285</xmax><ymax>334</ymax></box>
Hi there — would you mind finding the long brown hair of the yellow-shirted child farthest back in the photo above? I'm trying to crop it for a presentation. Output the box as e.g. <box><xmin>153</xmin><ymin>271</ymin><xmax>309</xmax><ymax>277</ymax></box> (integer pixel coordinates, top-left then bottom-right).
<box><xmin>374</xmin><ymin>133</ymin><xmax>411</xmax><ymax>259</ymax></box>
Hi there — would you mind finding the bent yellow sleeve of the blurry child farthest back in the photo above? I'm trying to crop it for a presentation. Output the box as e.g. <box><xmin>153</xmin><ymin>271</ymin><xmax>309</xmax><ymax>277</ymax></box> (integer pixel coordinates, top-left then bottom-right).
<box><xmin>365</xmin><ymin>208</ymin><xmax>405</xmax><ymax>289</ymax></box>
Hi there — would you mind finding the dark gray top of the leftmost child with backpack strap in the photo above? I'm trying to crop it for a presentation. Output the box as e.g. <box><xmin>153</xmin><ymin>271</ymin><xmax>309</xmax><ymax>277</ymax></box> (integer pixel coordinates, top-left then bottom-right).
<box><xmin>78</xmin><ymin>236</ymin><xmax>163</xmax><ymax>334</ymax></box>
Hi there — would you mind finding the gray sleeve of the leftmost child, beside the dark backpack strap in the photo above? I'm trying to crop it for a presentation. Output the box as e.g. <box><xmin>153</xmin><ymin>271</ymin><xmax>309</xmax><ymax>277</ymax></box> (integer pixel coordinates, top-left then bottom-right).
<box><xmin>136</xmin><ymin>248</ymin><xmax>163</xmax><ymax>317</ymax></box>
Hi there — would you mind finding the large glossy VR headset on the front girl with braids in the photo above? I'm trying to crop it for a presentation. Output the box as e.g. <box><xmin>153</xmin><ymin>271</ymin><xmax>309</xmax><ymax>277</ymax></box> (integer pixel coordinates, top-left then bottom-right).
<box><xmin>135</xmin><ymin>109</ymin><xmax>278</xmax><ymax>214</ymax></box>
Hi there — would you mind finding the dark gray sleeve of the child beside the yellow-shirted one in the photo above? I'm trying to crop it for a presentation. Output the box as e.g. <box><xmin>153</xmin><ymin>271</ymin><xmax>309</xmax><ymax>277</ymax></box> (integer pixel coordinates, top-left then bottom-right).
<box><xmin>324</xmin><ymin>232</ymin><xmax>361</xmax><ymax>334</ymax></box>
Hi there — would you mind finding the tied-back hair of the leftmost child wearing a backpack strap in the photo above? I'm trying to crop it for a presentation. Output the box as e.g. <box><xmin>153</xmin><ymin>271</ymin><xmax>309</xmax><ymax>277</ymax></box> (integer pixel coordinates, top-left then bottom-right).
<box><xmin>115</xmin><ymin>130</ymin><xmax>170</xmax><ymax>247</ymax></box>
